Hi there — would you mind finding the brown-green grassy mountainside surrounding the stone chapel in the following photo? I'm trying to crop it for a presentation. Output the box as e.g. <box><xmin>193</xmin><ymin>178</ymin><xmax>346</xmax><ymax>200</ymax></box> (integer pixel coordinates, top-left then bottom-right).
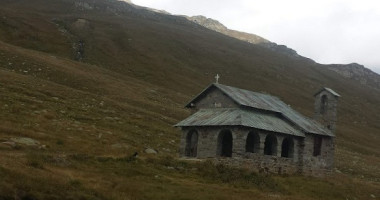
<box><xmin>0</xmin><ymin>0</ymin><xmax>380</xmax><ymax>199</ymax></box>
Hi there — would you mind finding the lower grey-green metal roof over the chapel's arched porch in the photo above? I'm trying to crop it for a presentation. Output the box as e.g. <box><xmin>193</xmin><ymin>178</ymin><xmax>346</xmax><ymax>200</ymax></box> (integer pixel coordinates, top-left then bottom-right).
<box><xmin>175</xmin><ymin>108</ymin><xmax>305</xmax><ymax>137</ymax></box>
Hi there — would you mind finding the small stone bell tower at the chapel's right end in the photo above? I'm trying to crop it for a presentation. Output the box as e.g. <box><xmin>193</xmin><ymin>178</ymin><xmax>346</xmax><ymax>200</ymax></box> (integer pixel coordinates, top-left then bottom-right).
<box><xmin>314</xmin><ymin>88</ymin><xmax>340</xmax><ymax>133</ymax></box>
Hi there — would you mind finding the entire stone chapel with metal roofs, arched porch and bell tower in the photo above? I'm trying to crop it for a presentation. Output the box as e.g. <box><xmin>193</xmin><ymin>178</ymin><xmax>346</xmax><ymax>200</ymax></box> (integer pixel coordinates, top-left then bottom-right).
<box><xmin>175</xmin><ymin>83</ymin><xmax>340</xmax><ymax>175</ymax></box>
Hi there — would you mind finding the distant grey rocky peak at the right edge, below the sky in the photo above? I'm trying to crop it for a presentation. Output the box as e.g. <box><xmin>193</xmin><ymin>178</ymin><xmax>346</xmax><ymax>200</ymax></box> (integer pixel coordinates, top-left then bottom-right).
<box><xmin>327</xmin><ymin>63</ymin><xmax>380</xmax><ymax>89</ymax></box>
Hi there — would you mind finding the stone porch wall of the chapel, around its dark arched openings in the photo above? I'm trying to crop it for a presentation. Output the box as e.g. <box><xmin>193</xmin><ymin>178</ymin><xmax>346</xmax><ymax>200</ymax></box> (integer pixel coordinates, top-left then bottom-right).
<box><xmin>180</xmin><ymin>127</ymin><xmax>304</xmax><ymax>174</ymax></box>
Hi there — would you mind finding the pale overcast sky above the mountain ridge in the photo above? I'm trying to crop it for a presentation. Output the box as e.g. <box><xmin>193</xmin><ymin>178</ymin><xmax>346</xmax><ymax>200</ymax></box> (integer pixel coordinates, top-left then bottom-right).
<box><xmin>132</xmin><ymin>0</ymin><xmax>380</xmax><ymax>72</ymax></box>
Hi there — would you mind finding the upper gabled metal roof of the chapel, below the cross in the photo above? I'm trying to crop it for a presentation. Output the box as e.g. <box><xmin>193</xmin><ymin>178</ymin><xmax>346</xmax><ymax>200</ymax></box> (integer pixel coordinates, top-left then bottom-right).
<box><xmin>186</xmin><ymin>84</ymin><xmax>334</xmax><ymax>136</ymax></box>
